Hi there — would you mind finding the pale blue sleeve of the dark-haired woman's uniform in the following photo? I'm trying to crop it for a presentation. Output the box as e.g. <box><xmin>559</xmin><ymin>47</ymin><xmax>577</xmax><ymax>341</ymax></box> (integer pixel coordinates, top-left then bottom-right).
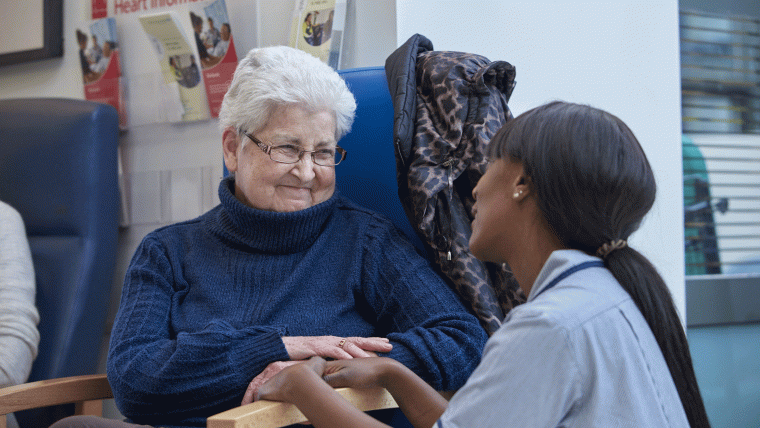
<box><xmin>436</xmin><ymin>308</ymin><xmax>583</xmax><ymax>428</ymax></box>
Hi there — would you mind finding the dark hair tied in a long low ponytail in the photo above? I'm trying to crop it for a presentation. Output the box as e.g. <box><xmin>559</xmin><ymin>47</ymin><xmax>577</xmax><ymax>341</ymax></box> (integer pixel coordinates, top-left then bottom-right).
<box><xmin>489</xmin><ymin>101</ymin><xmax>709</xmax><ymax>428</ymax></box>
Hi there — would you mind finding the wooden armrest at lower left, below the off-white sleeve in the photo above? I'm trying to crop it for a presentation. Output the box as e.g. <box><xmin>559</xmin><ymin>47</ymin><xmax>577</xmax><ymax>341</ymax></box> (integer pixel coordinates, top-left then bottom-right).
<box><xmin>0</xmin><ymin>374</ymin><xmax>113</xmax><ymax>415</ymax></box>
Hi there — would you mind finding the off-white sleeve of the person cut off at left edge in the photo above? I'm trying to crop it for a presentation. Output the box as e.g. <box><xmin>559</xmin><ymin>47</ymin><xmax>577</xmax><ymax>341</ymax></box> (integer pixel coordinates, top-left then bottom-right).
<box><xmin>0</xmin><ymin>202</ymin><xmax>40</xmax><ymax>387</ymax></box>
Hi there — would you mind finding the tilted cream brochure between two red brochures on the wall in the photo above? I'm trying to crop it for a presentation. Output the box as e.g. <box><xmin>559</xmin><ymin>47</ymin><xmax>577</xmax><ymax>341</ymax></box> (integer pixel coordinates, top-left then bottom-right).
<box><xmin>139</xmin><ymin>12</ymin><xmax>208</xmax><ymax>121</ymax></box>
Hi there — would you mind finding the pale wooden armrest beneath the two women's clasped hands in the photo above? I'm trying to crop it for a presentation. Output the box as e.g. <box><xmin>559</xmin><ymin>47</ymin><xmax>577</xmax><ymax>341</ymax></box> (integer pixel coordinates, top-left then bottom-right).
<box><xmin>206</xmin><ymin>388</ymin><xmax>398</xmax><ymax>428</ymax></box>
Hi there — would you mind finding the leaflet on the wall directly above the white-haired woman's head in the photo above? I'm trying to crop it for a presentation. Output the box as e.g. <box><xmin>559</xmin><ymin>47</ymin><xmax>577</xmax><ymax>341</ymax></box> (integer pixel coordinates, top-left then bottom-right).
<box><xmin>290</xmin><ymin>0</ymin><xmax>346</xmax><ymax>70</ymax></box>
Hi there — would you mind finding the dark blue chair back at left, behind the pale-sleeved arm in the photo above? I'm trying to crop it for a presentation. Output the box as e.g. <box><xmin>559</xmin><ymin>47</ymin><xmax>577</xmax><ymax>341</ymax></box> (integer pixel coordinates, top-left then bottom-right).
<box><xmin>0</xmin><ymin>99</ymin><xmax>119</xmax><ymax>428</ymax></box>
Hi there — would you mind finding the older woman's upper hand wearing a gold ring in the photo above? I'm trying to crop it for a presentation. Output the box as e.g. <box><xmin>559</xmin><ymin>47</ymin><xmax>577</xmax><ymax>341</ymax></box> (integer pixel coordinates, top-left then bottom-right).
<box><xmin>282</xmin><ymin>336</ymin><xmax>393</xmax><ymax>360</ymax></box>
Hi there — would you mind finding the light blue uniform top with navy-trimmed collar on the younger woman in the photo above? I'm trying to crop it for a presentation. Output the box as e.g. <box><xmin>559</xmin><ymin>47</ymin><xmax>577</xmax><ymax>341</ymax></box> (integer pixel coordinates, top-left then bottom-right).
<box><xmin>436</xmin><ymin>250</ymin><xmax>689</xmax><ymax>428</ymax></box>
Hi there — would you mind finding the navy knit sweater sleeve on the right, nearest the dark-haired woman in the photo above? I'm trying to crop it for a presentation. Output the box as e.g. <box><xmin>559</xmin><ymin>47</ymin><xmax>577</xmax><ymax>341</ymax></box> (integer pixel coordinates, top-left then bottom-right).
<box><xmin>363</xmin><ymin>216</ymin><xmax>488</xmax><ymax>391</ymax></box>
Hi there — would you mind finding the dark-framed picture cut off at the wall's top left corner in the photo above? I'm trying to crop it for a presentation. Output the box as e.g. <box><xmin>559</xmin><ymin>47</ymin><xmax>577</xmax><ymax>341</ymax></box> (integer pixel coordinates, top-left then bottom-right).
<box><xmin>0</xmin><ymin>0</ymin><xmax>63</xmax><ymax>66</ymax></box>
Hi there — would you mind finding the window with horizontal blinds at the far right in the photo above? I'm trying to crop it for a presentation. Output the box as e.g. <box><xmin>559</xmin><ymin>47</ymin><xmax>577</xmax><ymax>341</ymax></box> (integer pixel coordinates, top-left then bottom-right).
<box><xmin>681</xmin><ymin>10</ymin><xmax>760</xmax><ymax>275</ymax></box>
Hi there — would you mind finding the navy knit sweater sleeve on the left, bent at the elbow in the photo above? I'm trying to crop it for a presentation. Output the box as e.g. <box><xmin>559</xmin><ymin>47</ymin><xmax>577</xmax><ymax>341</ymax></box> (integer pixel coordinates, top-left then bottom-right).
<box><xmin>107</xmin><ymin>235</ymin><xmax>287</xmax><ymax>425</ymax></box>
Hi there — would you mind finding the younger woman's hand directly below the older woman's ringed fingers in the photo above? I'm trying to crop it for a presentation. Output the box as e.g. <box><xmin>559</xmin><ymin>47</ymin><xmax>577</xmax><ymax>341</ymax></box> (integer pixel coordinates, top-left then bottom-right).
<box><xmin>322</xmin><ymin>358</ymin><xmax>400</xmax><ymax>388</ymax></box>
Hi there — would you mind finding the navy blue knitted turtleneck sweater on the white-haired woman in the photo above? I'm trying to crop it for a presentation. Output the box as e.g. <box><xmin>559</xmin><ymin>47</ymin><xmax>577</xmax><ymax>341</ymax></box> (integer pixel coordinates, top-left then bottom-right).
<box><xmin>107</xmin><ymin>179</ymin><xmax>487</xmax><ymax>426</ymax></box>
